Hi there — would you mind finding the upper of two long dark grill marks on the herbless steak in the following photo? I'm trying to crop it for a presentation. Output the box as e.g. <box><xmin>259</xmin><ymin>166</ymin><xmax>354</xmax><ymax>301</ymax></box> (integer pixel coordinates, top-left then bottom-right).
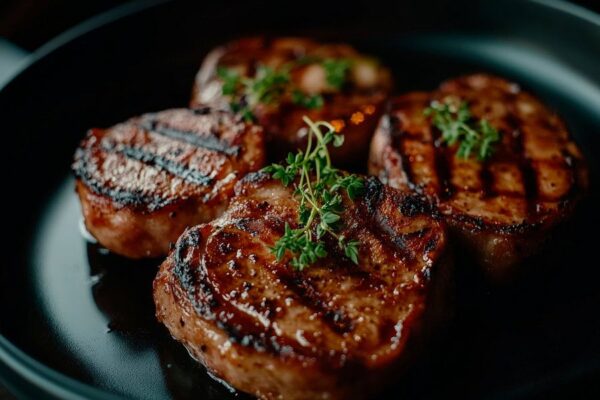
<box><xmin>139</xmin><ymin>119</ymin><xmax>240</xmax><ymax>156</ymax></box>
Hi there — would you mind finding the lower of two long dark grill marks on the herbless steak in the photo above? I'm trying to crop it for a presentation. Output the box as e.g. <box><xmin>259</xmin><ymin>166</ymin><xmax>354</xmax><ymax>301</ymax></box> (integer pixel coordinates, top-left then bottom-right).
<box><xmin>103</xmin><ymin>145</ymin><xmax>213</xmax><ymax>186</ymax></box>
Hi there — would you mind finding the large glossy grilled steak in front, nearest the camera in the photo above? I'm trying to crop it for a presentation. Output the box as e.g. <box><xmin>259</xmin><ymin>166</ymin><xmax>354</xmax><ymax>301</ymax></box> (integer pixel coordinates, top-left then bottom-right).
<box><xmin>154</xmin><ymin>173</ymin><xmax>449</xmax><ymax>399</ymax></box>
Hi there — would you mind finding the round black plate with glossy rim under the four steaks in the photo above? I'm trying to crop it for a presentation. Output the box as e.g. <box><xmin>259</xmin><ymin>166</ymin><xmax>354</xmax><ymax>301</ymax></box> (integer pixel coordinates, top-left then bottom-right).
<box><xmin>0</xmin><ymin>0</ymin><xmax>600</xmax><ymax>399</ymax></box>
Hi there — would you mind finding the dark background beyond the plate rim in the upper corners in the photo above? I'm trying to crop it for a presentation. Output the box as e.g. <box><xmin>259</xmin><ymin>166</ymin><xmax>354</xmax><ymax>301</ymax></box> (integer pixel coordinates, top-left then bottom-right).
<box><xmin>0</xmin><ymin>0</ymin><xmax>600</xmax><ymax>400</ymax></box>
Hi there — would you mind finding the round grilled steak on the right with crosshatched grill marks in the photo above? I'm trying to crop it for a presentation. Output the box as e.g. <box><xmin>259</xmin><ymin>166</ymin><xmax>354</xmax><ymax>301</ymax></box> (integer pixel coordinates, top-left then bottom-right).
<box><xmin>369</xmin><ymin>74</ymin><xmax>588</xmax><ymax>280</ymax></box>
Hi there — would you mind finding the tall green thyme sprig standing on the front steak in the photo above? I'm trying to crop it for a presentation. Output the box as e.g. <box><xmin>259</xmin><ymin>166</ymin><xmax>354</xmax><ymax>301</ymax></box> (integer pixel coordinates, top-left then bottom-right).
<box><xmin>263</xmin><ymin>116</ymin><xmax>364</xmax><ymax>270</ymax></box>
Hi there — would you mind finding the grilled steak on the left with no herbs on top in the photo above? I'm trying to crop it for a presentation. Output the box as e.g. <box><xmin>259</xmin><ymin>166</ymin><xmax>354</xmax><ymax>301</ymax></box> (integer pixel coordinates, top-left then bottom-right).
<box><xmin>73</xmin><ymin>107</ymin><xmax>265</xmax><ymax>258</ymax></box>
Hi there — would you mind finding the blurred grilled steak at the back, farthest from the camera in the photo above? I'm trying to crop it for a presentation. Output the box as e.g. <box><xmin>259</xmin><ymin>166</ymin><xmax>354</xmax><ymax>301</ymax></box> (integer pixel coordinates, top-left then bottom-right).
<box><xmin>191</xmin><ymin>38</ymin><xmax>392</xmax><ymax>165</ymax></box>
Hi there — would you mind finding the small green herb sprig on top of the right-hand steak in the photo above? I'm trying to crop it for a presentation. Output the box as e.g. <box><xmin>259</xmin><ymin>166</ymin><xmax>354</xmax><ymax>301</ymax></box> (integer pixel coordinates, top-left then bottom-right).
<box><xmin>424</xmin><ymin>101</ymin><xmax>500</xmax><ymax>160</ymax></box>
